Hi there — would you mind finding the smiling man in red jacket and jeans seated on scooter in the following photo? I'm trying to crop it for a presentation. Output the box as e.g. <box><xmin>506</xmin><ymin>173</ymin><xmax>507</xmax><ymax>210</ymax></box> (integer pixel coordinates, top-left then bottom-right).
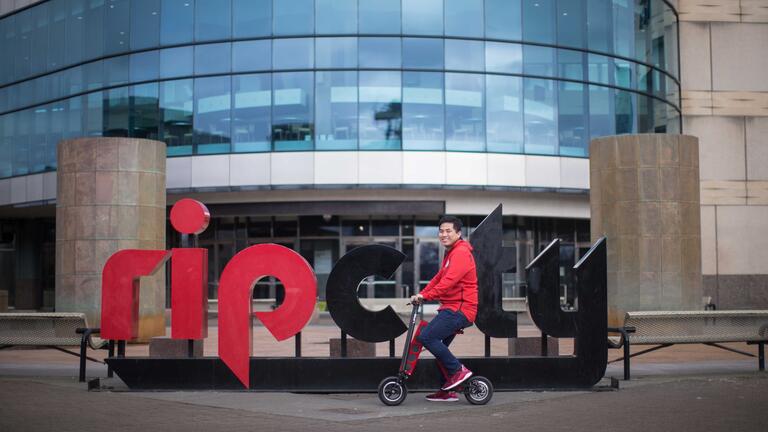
<box><xmin>411</xmin><ymin>216</ymin><xmax>477</xmax><ymax>402</ymax></box>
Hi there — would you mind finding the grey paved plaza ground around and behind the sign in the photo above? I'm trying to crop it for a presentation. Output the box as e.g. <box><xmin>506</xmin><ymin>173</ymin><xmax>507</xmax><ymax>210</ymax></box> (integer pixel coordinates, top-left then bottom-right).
<box><xmin>0</xmin><ymin>318</ymin><xmax>768</xmax><ymax>432</ymax></box>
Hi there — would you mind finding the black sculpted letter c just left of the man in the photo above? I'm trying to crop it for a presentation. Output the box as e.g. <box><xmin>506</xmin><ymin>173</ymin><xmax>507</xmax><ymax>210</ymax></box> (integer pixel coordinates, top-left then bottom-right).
<box><xmin>325</xmin><ymin>244</ymin><xmax>408</xmax><ymax>342</ymax></box>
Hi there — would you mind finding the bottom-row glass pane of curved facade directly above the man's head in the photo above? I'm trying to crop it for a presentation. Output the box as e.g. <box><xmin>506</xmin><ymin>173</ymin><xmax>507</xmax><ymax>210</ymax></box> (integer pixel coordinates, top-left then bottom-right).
<box><xmin>445</xmin><ymin>73</ymin><xmax>485</xmax><ymax>151</ymax></box>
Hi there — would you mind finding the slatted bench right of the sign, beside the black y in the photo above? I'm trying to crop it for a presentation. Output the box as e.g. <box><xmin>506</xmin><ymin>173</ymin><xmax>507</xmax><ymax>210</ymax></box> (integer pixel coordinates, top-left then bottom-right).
<box><xmin>608</xmin><ymin>310</ymin><xmax>768</xmax><ymax>380</ymax></box>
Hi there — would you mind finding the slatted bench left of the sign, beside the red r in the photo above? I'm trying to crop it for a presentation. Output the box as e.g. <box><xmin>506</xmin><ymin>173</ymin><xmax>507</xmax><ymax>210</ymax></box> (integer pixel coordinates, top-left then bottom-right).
<box><xmin>0</xmin><ymin>312</ymin><xmax>108</xmax><ymax>382</ymax></box>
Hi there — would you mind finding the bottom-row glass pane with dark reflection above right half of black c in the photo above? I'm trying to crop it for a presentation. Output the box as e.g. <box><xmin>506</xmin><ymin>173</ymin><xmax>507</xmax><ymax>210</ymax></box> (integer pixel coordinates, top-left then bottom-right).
<box><xmin>359</xmin><ymin>71</ymin><xmax>402</xmax><ymax>150</ymax></box>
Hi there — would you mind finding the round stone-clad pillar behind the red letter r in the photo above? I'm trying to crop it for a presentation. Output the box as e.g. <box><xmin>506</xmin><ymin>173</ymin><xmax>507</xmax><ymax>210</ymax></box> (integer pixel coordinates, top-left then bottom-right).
<box><xmin>56</xmin><ymin>137</ymin><xmax>166</xmax><ymax>340</ymax></box>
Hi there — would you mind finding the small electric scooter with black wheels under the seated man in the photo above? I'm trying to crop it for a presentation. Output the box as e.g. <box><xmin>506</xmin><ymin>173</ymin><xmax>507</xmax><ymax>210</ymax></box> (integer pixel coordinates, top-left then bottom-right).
<box><xmin>379</xmin><ymin>303</ymin><xmax>493</xmax><ymax>406</ymax></box>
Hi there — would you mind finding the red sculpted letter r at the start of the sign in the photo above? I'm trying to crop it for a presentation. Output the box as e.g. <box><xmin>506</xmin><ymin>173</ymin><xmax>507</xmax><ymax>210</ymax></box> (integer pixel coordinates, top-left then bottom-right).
<box><xmin>101</xmin><ymin>249</ymin><xmax>171</xmax><ymax>340</ymax></box>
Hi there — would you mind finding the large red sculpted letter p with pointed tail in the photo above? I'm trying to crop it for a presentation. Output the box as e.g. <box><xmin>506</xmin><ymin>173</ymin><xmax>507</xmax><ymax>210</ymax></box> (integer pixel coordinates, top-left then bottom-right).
<box><xmin>219</xmin><ymin>244</ymin><xmax>317</xmax><ymax>388</ymax></box>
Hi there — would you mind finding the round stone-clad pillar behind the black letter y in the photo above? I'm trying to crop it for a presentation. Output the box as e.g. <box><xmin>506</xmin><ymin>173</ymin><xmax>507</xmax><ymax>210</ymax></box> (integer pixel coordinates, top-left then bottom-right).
<box><xmin>589</xmin><ymin>134</ymin><xmax>702</xmax><ymax>325</ymax></box>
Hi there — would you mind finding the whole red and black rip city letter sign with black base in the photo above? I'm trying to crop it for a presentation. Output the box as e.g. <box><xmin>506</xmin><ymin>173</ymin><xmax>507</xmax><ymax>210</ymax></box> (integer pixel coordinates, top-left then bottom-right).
<box><xmin>101</xmin><ymin>199</ymin><xmax>607</xmax><ymax>392</ymax></box>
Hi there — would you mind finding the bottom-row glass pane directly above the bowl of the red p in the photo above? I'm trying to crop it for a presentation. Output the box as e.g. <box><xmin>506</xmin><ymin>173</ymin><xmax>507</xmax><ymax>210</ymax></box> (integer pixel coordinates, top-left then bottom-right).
<box><xmin>272</xmin><ymin>72</ymin><xmax>314</xmax><ymax>151</ymax></box>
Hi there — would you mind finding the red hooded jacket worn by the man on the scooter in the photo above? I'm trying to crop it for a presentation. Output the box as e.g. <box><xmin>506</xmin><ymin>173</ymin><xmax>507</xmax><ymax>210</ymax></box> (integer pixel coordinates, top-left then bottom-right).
<box><xmin>420</xmin><ymin>239</ymin><xmax>477</xmax><ymax>323</ymax></box>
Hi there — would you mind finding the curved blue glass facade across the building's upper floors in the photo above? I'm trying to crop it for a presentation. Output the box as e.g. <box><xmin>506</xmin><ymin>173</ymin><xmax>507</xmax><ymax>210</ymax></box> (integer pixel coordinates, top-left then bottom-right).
<box><xmin>0</xmin><ymin>0</ymin><xmax>680</xmax><ymax>178</ymax></box>
